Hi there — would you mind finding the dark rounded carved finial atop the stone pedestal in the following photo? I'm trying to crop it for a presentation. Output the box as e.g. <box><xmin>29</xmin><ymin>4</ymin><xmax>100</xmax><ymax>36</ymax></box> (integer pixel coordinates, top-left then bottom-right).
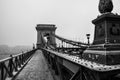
<box><xmin>99</xmin><ymin>0</ymin><xmax>113</xmax><ymax>14</ymax></box>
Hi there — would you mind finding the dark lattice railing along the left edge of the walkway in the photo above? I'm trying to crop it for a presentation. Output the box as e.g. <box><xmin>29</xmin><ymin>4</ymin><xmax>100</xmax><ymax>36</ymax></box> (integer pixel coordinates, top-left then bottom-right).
<box><xmin>0</xmin><ymin>49</ymin><xmax>36</xmax><ymax>80</ymax></box>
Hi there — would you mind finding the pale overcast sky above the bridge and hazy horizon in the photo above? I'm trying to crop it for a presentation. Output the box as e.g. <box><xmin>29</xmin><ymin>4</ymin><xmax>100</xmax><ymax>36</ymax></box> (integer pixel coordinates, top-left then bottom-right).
<box><xmin>0</xmin><ymin>0</ymin><xmax>120</xmax><ymax>46</ymax></box>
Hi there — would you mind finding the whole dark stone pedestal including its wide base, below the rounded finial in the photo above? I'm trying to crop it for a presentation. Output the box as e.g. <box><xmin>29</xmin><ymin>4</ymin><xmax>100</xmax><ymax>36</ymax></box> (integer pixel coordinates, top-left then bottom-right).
<box><xmin>83</xmin><ymin>13</ymin><xmax>120</xmax><ymax>65</ymax></box>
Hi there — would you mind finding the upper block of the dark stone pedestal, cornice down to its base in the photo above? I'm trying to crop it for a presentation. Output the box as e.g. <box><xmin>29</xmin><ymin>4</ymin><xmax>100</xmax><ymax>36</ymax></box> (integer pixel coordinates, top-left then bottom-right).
<box><xmin>92</xmin><ymin>13</ymin><xmax>120</xmax><ymax>44</ymax></box>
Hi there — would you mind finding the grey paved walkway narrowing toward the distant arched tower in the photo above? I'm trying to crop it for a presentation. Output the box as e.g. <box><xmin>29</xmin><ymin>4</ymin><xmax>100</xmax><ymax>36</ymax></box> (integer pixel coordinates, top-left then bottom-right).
<box><xmin>15</xmin><ymin>50</ymin><xmax>54</xmax><ymax>80</ymax></box>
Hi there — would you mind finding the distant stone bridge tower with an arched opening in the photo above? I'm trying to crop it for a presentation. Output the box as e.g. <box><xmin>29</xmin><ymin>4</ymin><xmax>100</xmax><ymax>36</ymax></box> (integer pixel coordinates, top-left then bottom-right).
<box><xmin>36</xmin><ymin>24</ymin><xmax>56</xmax><ymax>48</ymax></box>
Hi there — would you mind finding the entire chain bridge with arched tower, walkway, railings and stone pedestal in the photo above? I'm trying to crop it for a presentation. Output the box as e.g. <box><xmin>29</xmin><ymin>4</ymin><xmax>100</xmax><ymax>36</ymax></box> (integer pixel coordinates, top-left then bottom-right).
<box><xmin>0</xmin><ymin>0</ymin><xmax>120</xmax><ymax>80</ymax></box>
